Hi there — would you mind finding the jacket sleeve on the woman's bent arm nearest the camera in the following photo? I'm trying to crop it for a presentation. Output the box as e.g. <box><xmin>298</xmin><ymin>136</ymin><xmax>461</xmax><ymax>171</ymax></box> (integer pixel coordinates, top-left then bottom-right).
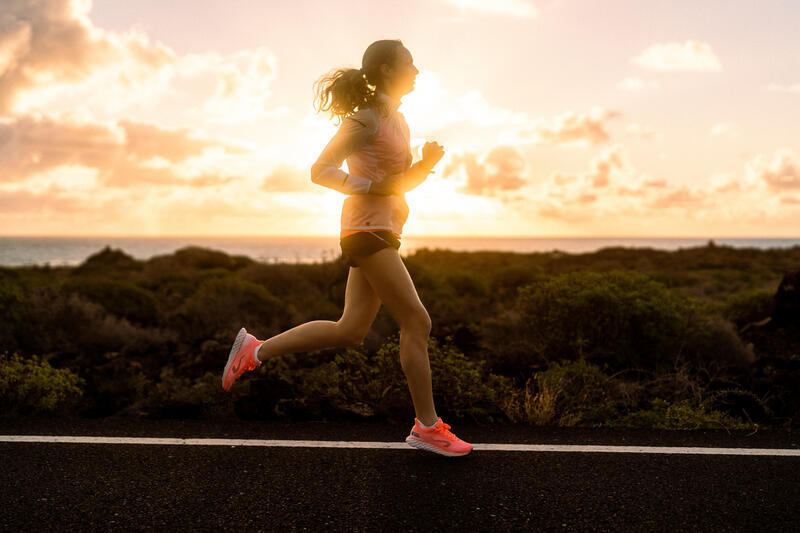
<box><xmin>311</xmin><ymin>109</ymin><xmax>378</xmax><ymax>194</ymax></box>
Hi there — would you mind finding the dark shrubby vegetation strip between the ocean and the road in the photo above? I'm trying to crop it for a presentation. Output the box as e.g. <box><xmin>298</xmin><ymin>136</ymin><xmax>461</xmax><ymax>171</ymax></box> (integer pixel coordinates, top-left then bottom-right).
<box><xmin>0</xmin><ymin>242</ymin><xmax>800</xmax><ymax>430</ymax></box>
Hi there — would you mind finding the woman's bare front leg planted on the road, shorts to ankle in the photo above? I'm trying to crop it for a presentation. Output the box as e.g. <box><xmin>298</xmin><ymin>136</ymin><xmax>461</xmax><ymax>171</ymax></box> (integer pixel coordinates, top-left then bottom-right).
<box><xmin>358</xmin><ymin>248</ymin><xmax>437</xmax><ymax>425</ymax></box>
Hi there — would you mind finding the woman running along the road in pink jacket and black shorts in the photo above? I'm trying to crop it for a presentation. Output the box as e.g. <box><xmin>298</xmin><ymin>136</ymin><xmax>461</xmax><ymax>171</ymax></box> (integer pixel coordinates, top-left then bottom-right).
<box><xmin>222</xmin><ymin>40</ymin><xmax>472</xmax><ymax>456</ymax></box>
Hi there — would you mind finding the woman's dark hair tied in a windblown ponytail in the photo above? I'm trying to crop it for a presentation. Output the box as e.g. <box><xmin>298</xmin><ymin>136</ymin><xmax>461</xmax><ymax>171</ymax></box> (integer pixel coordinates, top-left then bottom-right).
<box><xmin>314</xmin><ymin>39</ymin><xmax>403</xmax><ymax>121</ymax></box>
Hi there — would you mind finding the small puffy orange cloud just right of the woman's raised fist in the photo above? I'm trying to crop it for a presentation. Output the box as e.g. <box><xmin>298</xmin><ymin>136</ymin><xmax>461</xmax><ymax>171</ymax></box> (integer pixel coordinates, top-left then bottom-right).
<box><xmin>442</xmin><ymin>146</ymin><xmax>526</xmax><ymax>196</ymax></box>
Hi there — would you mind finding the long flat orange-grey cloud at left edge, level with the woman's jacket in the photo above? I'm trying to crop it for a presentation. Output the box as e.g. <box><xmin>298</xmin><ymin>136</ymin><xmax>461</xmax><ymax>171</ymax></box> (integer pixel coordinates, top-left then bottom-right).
<box><xmin>0</xmin><ymin>114</ymin><xmax>243</xmax><ymax>187</ymax></box>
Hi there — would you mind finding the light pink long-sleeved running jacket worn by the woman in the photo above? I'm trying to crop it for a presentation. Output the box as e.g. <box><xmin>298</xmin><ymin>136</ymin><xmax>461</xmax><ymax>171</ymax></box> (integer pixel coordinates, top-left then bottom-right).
<box><xmin>311</xmin><ymin>91</ymin><xmax>426</xmax><ymax>238</ymax></box>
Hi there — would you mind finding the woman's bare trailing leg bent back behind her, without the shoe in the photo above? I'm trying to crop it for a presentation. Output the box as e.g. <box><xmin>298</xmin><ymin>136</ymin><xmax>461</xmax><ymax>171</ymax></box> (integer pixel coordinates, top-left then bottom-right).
<box><xmin>258</xmin><ymin>267</ymin><xmax>381</xmax><ymax>361</ymax></box>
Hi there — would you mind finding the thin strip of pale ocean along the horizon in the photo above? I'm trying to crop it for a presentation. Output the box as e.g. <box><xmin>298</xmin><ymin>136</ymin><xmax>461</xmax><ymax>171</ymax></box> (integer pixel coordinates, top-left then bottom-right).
<box><xmin>0</xmin><ymin>235</ymin><xmax>800</xmax><ymax>266</ymax></box>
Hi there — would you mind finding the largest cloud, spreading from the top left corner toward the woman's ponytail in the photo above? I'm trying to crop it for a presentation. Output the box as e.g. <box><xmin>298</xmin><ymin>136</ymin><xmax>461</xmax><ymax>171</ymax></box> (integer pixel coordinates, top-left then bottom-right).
<box><xmin>0</xmin><ymin>0</ymin><xmax>282</xmax><ymax>124</ymax></box>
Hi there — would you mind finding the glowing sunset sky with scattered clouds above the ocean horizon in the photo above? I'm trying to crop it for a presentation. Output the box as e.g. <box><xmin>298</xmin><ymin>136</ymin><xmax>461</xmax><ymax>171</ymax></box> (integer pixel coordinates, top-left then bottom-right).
<box><xmin>0</xmin><ymin>0</ymin><xmax>800</xmax><ymax>238</ymax></box>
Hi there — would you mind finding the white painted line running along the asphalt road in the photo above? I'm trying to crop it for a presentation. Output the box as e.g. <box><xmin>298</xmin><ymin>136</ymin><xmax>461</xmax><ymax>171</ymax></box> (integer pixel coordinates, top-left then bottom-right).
<box><xmin>0</xmin><ymin>435</ymin><xmax>800</xmax><ymax>457</ymax></box>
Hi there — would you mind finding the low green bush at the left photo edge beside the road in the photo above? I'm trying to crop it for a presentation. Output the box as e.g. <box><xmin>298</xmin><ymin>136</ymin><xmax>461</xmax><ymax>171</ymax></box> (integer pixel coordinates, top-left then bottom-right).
<box><xmin>0</xmin><ymin>352</ymin><xmax>84</xmax><ymax>415</ymax></box>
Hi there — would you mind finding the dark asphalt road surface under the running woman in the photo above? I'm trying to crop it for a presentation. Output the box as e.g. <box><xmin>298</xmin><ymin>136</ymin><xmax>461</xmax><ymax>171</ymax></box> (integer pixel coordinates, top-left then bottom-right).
<box><xmin>0</xmin><ymin>419</ymin><xmax>800</xmax><ymax>531</ymax></box>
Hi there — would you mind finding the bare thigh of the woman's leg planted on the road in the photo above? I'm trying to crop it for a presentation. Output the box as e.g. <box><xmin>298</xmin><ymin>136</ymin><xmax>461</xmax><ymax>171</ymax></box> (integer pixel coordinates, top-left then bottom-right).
<box><xmin>358</xmin><ymin>247</ymin><xmax>431</xmax><ymax>333</ymax></box>
